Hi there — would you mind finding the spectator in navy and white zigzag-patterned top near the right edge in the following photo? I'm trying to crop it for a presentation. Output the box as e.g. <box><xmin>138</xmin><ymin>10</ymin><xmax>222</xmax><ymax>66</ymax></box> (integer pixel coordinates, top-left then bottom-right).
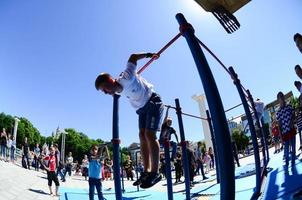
<box><xmin>276</xmin><ymin>92</ymin><xmax>296</xmax><ymax>167</ymax></box>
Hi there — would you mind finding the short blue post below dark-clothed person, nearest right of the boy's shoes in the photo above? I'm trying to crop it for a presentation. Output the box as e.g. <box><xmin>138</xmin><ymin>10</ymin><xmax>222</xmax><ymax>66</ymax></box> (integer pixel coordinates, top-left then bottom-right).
<box><xmin>164</xmin><ymin>137</ymin><xmax>173</xmax><ymax>200</ymax></box>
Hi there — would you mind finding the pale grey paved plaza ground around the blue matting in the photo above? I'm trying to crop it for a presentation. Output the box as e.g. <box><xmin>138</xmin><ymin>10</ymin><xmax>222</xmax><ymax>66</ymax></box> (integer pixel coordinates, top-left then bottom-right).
<box><xmin>0</xmin><ymin>152</ymin><xmax>260</xmax><ymax>200</ymax></box>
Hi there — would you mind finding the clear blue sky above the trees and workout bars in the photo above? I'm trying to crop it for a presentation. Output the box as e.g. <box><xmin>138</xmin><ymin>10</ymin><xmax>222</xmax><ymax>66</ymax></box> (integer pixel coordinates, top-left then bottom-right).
<box><xmin>0</xmin><ymin>0</ymin><xmax>302</xmax><ymax>145</ymax></box>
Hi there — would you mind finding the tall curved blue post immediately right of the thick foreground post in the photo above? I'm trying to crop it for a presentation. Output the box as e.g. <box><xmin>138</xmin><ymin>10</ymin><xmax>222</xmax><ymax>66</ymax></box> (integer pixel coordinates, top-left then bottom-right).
<box><xmin>229</xmin><ymin>67</ymin><xmax>261</xmax><ymax>199</ymax></box>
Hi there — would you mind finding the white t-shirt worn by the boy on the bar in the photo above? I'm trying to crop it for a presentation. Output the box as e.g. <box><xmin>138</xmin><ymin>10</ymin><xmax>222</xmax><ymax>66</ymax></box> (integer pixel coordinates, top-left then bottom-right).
<box><xmin>117</xmin><ymin>62</ymin><xmax>154</xmax><ymax>109</ymax></box>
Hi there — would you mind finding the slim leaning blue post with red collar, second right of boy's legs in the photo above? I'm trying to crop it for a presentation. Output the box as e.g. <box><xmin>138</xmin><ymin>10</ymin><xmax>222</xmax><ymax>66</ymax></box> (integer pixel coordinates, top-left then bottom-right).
<box><xmin>175</xmin><ymin>99</ymin><xmax>191</xmax><ymax>200</ymax></box>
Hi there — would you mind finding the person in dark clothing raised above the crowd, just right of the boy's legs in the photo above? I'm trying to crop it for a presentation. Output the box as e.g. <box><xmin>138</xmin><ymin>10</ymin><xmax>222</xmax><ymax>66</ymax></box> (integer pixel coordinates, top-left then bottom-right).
<box><xmin>159</xmin><ymin>117</ymin><xmax>179</xmax><ymax>161</ymax></box>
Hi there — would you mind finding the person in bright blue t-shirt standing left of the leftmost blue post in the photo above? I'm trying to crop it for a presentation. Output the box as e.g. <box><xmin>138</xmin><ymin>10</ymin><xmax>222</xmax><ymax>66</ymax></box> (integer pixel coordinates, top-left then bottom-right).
<box><xmin>88</xmin><ymin>145</ymin><xmax>104</xmax><ymax>200</ymax></box>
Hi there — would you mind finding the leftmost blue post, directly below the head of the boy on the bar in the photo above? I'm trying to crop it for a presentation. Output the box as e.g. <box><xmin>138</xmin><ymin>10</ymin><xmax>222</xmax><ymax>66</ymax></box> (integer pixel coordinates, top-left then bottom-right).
<box><xmin>111</xmin><ymin>94</ymin><xmax>123</xmax><ymax>200</ymax></box>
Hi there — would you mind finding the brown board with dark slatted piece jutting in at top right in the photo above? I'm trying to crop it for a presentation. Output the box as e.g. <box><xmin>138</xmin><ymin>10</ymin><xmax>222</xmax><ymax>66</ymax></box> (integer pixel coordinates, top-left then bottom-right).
<box><xmin>195</xmin><ymin>0</ymin><xmax>251</xmax><ymax>33</ymax></box>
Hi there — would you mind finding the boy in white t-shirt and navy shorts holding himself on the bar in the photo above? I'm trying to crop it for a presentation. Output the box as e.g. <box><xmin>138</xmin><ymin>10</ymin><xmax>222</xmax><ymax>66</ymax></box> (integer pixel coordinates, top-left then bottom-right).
<box><xmin>95</xmin><ymin>53</ymin><xmax>164</xmax><ymax>188</ymax></box>
